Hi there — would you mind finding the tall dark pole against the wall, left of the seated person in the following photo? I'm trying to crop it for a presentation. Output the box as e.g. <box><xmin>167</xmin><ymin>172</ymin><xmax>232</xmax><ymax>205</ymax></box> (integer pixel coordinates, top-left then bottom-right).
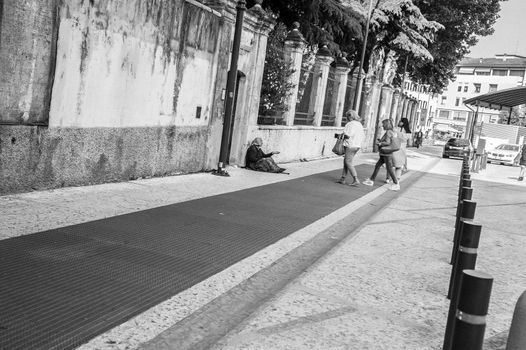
<box><xmin>212</xmin><ymin>0</ymin><xmax>247</xmax><ymax>176</ymax></box>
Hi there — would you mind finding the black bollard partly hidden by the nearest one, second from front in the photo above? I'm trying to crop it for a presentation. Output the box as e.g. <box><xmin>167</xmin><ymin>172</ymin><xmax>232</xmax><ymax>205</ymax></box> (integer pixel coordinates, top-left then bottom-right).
<box><xmin>447</xmin><ymin>220</ymin><xmax>482</xmax><ymax>299</ymax></box>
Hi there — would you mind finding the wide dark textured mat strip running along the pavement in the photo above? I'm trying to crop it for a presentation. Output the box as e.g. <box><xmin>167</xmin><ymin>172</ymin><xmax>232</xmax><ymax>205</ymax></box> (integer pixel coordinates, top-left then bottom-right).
<box><xmin>0</xmin><ymin>165</ymin><xmax>383</xmax><ymax>350</ymax></box>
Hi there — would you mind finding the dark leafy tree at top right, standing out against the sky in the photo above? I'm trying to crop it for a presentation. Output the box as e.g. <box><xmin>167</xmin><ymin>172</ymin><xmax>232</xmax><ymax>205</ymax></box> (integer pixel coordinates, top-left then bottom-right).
<box><xmin>408</xmin><ymin>0</ymin><xmax>505</xmax><ymax>93</ymax></box>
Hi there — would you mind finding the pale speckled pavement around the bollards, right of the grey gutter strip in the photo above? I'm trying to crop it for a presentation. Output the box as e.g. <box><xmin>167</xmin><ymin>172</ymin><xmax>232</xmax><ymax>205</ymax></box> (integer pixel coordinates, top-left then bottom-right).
<box><xmin>203</xmin><ymin>165</ymin><xmax>526</xmax><ymax>350</ymax></box>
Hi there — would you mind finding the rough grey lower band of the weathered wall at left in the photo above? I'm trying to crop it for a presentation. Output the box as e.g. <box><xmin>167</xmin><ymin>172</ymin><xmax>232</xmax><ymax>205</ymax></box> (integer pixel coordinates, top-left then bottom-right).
<box><xmin>0</xmin><ymin>126</ymin><xmax>207</xmax><ymax>193</ymax></box>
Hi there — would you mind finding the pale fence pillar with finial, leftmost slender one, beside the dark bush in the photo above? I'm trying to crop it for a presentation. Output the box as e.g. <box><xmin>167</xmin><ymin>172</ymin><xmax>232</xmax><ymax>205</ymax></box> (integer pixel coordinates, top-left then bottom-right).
<box><xmin>283</xmin><ymin>22</ymin><xmax>305</xmax><ymax>125</ymax></box>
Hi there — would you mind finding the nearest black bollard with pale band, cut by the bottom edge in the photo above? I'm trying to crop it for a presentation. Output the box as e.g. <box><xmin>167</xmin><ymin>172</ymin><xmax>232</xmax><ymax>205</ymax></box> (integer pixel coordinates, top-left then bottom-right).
<box><xmin>451</xmin><ymin>270</ymin><xmax>493</xmax><ymax>350</ymax></box>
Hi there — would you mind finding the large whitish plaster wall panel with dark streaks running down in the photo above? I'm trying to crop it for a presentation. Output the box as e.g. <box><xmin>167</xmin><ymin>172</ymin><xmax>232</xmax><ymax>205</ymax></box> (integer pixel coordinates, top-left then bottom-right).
<box><xmin>50</xmin><ymin>0</ymin><xmax>220</xmax><ymax>127</ymax></box>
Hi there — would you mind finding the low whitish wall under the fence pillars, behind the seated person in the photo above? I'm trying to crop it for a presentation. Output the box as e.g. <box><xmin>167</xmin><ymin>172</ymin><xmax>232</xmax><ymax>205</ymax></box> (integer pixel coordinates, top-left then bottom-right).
<box><xmin>250</xmin><ymin>125</ymin><xmax>343</xmax><ymax>162</ymax></box>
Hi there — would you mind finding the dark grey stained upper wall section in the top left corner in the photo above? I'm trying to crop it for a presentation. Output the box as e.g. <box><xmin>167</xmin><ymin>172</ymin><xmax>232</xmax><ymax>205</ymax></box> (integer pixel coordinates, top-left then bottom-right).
<box><xmin>0</xmin><ymin>0</ymin><xmax>57</xmax><ymax>124</ymax></box>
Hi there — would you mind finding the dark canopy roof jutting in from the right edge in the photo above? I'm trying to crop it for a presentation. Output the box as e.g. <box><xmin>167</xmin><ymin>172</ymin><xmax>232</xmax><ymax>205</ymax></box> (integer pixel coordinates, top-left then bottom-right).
<box><xmin>464</xmin><ymin>86</ymin><xmax>526</xmax><ymax>110</ymax></box>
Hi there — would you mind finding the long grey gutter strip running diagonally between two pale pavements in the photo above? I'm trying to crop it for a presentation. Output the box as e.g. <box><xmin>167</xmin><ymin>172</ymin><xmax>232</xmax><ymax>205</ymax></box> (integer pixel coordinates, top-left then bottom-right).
<box><xmin>139</xmin><ymin>160</ymin><xmax>438</xmax><ymax>350</ymax></box>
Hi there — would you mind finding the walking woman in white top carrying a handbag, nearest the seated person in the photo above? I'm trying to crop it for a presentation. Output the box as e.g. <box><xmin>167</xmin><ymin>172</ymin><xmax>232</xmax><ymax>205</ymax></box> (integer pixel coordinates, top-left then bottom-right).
<box><xmin>337</xmin><ymin>109</ymin><xmax>364</xmax><ymax>187</ymax></box>
